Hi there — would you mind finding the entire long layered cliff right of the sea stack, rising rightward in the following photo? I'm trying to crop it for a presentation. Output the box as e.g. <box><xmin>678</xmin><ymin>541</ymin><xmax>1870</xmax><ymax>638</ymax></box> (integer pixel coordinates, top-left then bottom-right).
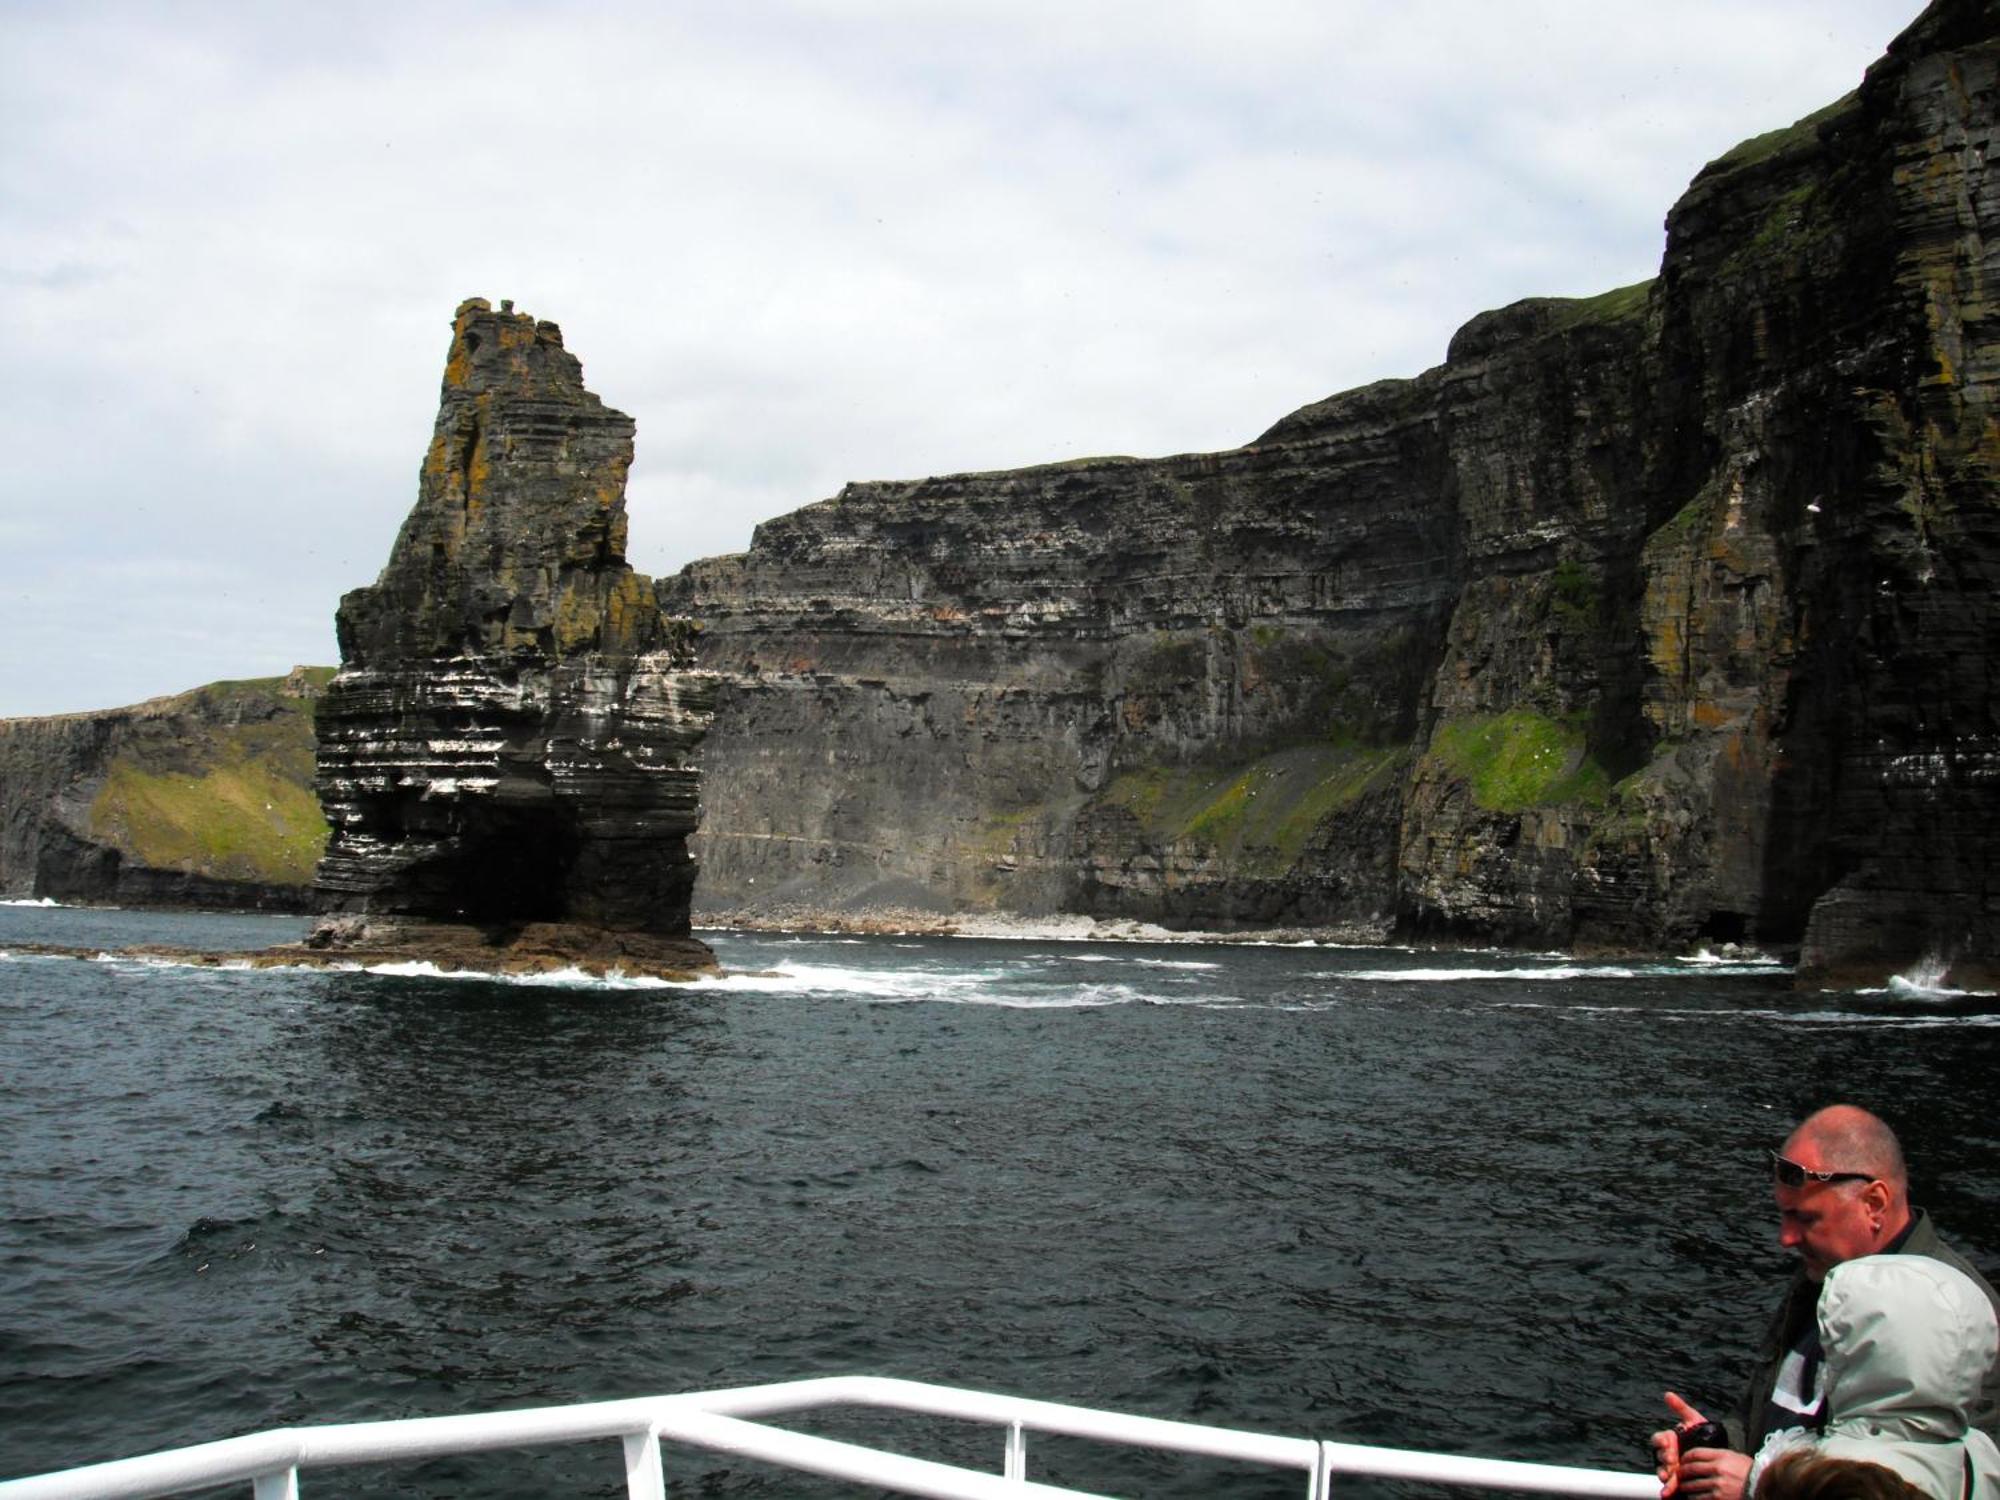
<box><xmin>662</xmin><ymin>0</ymin><xmax>2000</xmax><ymax>992</ymax></box>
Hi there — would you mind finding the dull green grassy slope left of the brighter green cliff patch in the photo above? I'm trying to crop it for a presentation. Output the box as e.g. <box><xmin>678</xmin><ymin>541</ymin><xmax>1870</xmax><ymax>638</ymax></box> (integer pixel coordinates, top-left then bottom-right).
<box><xmin>1102</xmin><ymin>744</ymin><xmax>1402</xmax><ymax>876</ymax></box>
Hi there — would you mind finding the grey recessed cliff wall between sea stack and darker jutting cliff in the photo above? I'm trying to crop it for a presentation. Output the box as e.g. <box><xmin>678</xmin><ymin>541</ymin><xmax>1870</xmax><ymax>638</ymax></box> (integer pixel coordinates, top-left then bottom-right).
<box><xmin>670</xmin><ymin>412</ymin><xmax>1454</xmax><ymax>926</ymax></box>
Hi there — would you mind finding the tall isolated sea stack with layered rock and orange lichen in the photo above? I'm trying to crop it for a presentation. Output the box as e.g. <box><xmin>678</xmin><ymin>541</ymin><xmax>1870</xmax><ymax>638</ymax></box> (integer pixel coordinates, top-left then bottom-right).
<box><xmin>318</xmin><ymin>298</ymin><xmax>714</xmax><ymax>952</ymax></box>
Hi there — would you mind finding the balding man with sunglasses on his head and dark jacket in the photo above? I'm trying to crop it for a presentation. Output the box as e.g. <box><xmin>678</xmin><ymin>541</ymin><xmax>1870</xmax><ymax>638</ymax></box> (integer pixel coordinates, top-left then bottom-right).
<box><xmin>1652</xmin><ymin>1104</ymin><xmax>2000</xmax><ymax>1500</ymax></box>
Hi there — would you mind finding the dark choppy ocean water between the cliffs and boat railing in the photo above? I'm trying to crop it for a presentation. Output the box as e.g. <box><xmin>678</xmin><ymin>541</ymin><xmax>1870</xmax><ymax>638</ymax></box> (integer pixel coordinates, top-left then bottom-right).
<box><xmin>0</xmin><ymin>906</ymin><xmax>2000</xmax><ymax>1496</ymax></box>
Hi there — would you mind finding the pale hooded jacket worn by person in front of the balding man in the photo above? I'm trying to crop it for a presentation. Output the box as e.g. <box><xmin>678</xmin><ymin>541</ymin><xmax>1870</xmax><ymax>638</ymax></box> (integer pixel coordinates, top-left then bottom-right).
<box><xmin>1748</xmin><ymin>1256</ymin><xmax>2000</xmax><ymax>1500</ymax></box>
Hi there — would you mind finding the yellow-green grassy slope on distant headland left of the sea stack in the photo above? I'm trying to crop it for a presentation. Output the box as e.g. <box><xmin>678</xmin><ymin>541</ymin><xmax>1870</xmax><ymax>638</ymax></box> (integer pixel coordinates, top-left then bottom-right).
<box><xmin>90</xmin><ymin>668</ymin><xmax>332</xmax><ymax>886</ymax></box>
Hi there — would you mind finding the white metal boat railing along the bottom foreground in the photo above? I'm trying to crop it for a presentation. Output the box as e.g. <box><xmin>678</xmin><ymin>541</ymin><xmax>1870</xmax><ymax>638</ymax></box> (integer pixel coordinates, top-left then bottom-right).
<box><xmin>0</xmin><ymin>1376</ymin><xmax>1660</xmax><ymax>1500</ymax></box>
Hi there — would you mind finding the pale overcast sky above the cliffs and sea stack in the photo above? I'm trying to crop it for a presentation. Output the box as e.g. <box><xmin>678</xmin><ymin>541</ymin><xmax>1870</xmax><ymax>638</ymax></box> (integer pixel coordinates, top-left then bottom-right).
<box><xmin>0</xmin><ymin>0</ymin><xmax>1920</xmax><ymax>716</ymax></box>
